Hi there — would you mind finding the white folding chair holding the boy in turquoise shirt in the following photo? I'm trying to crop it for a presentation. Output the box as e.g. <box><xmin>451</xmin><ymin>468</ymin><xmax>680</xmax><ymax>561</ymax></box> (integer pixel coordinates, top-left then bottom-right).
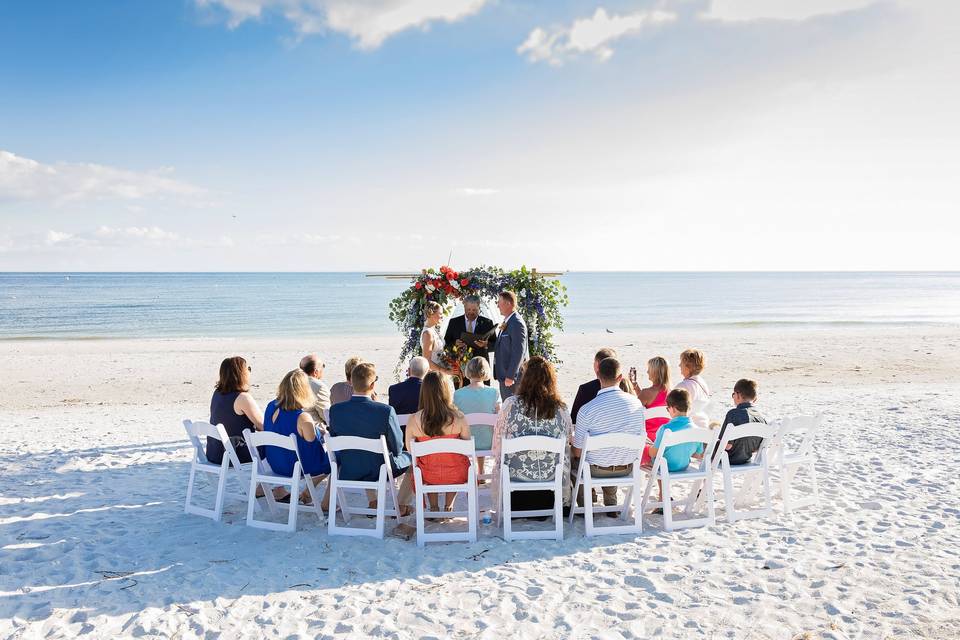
<box><xmin>641</xmin><ymin>427</ymin><xmax>717</xmax><ymax>531</ymax></box>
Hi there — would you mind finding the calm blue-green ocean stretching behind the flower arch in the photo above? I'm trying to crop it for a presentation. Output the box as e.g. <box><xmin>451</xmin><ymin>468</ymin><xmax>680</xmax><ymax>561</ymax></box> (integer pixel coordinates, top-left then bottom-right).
<box><xmin>0</xmin><ymin>272</ymin><xmax>960</xmax><ymax>340</ymax></box>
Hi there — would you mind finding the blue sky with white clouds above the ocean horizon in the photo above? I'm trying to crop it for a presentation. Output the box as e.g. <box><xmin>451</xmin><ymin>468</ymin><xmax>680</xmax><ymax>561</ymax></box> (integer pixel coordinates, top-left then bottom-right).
<box><xmin>0</xmin><ymin>0</ymin><xmax>960</xmax><ymax>271</ymax></box>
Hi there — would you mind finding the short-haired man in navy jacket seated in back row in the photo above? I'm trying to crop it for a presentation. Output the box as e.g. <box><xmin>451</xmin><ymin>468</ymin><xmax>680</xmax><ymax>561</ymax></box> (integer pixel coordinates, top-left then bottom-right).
<box><xmin>323</xmin><ymin>362</ymin><xmax>410</xmax><ymax>512</ymax></box>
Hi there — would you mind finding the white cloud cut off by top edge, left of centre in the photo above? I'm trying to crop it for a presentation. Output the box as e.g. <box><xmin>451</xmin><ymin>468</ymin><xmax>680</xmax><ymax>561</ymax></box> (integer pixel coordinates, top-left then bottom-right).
<box><xmin>196</xmin><ymin>0</ymin><xmax>489</xmax><ymax>50</ymax></box>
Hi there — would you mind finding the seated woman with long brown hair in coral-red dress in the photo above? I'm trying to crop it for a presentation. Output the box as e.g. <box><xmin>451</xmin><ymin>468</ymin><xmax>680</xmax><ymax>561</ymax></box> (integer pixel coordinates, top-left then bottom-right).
<box><xmin>407</xmin><ymin>372</ymin><xmax>470</xmax><ymax>511</ymax></box>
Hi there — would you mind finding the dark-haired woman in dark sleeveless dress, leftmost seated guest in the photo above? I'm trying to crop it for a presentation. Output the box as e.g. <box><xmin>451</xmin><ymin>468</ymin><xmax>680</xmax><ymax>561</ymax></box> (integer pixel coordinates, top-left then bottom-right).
<box><xmin>207</xmin><ymin>356</ymin><xmax>263</xmax><ymax>464</ymax></box>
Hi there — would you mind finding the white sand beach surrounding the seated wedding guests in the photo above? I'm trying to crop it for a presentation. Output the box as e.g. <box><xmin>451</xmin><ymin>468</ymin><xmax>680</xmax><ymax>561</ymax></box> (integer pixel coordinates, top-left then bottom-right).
<box><xmin>0</xmin><ymin>328</ymin><xmax>960</xmax><ymax>639</ymax></box>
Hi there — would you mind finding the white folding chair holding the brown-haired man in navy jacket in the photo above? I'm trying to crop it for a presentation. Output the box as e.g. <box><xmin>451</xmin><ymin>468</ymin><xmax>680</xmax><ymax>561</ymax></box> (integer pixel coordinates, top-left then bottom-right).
<box><xmin>324</xmin><ymin>436</ymin><xmax>400</xmax><ymax>538</ymax></box>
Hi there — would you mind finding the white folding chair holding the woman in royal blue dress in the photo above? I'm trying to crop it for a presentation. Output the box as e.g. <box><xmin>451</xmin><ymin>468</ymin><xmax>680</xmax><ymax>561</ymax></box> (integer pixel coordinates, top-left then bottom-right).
<box><xmin>243</xmin><ymin>429</ymin><xmax>324</xmax><ymax>531</ymax></box>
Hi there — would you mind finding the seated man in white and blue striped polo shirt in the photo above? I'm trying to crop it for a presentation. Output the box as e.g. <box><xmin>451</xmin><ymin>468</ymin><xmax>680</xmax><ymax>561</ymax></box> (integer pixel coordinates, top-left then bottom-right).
<box><xmin>570</xmin><ymin>358</ymin><xmax>646</xmax><ymax>510</ymax></box>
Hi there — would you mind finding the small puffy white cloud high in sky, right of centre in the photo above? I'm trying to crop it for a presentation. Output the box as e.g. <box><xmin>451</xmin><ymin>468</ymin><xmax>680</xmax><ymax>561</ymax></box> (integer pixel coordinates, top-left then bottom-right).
<box><xmin>517</xmin><ymin>7</ymin><xmax>677</xmax><ymax>66</ymax></box>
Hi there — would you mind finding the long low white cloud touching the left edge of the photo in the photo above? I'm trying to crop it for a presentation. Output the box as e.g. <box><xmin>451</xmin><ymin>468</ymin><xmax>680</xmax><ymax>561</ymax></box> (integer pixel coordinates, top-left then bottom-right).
<box><xmin>0</xmin><ymin>149</ymin><xmax>206</xmax><ymax>204</ymax></box>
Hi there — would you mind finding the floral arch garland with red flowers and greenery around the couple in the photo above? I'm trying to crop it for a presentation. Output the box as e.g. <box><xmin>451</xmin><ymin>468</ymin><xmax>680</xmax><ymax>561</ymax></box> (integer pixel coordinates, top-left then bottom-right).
<box><xmin>390</xmin><ymin>265</ymin><xmax>568</xmax><ymax>376</ymax></box>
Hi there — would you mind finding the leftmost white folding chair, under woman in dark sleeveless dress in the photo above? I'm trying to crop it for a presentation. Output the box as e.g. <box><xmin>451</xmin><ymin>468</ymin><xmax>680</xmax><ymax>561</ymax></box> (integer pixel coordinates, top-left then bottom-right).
<box><xmin>183</xmin><ymin>420</ymin><xmax>251</xmax><ymax>521</ymax></box>
